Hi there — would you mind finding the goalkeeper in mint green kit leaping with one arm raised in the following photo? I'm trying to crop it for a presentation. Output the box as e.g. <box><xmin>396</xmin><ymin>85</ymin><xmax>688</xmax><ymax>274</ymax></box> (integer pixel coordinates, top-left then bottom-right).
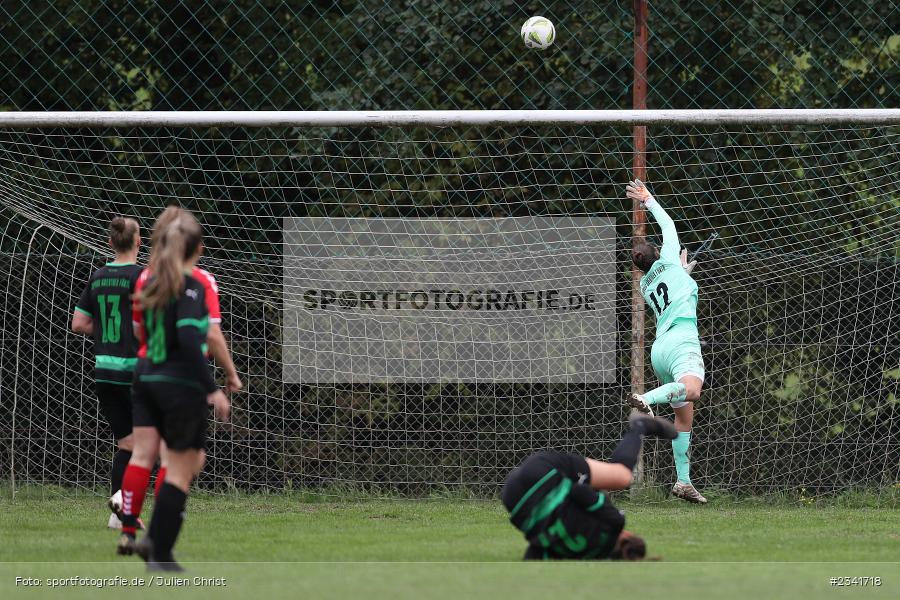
<box><xmin>626</xmin><ymin>179</ymin><xmax>706</xmax><ymax>504</ymax></box>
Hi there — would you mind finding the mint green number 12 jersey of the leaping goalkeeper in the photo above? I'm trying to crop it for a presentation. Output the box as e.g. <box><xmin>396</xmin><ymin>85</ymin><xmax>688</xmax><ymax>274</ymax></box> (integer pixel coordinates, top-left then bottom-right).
<box><xmin>641</xmin><ymin>200</ymin><xmax>697</xmax><ymax>337</ymax></box>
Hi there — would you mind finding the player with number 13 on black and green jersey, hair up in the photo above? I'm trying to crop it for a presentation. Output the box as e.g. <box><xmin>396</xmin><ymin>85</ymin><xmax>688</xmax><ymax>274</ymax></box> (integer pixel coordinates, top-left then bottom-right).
<box><xmin>72</xmin><ymin>217</ymin><xmax>141</xmax><ymax>529</ymax></box>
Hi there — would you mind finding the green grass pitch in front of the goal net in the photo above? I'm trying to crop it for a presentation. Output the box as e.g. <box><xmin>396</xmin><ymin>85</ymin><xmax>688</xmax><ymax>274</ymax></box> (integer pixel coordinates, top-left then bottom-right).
<box><xmin>0</xmin><ymin>490</ymin><xmax>900</xmax><ymax>600</ymax></box>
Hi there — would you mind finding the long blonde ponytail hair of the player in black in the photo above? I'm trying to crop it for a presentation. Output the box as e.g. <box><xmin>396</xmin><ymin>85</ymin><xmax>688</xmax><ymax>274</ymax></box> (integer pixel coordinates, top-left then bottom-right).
<box><xmin>138</xmin><ymin>206</ymin><xmax>203</xmax><ymax>309</ymax></box>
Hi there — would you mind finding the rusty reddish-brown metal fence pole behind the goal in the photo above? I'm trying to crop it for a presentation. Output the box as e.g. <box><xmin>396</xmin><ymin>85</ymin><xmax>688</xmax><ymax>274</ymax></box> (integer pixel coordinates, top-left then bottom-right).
<box><xmin>631</xmin><ymin>0</ymin><xmax>648</xmax><ymax>482</ymax></box>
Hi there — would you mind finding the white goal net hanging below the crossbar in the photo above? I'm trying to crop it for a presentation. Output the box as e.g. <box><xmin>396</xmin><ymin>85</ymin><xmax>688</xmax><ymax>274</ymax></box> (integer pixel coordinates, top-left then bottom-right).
<box><xmin>0</xmin><ymin>113</ymin><xmax>900</xmax><ymax>497</ymax></box>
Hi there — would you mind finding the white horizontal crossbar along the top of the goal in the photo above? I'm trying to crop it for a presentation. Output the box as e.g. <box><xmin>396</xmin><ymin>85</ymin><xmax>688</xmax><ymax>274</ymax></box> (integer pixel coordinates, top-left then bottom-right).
<box><xmin>0</xmin><ymin>108</ymin><xmax>900</xmax><ymax>128</ymax></box>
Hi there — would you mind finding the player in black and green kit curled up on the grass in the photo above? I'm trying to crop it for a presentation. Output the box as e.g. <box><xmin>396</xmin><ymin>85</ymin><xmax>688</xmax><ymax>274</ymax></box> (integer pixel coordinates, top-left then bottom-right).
<box><xmin>500</xmin><ymin>414</ymin><xmax>677</xmax><ymax>560</ymax></box>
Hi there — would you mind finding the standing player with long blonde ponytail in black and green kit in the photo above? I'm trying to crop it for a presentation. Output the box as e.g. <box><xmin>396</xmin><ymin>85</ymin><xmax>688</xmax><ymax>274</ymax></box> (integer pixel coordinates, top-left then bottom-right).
<box><xmin>118</xmin><ymin>207</ymin><xmax>230</xmax><ymax>571</ymax></box>
